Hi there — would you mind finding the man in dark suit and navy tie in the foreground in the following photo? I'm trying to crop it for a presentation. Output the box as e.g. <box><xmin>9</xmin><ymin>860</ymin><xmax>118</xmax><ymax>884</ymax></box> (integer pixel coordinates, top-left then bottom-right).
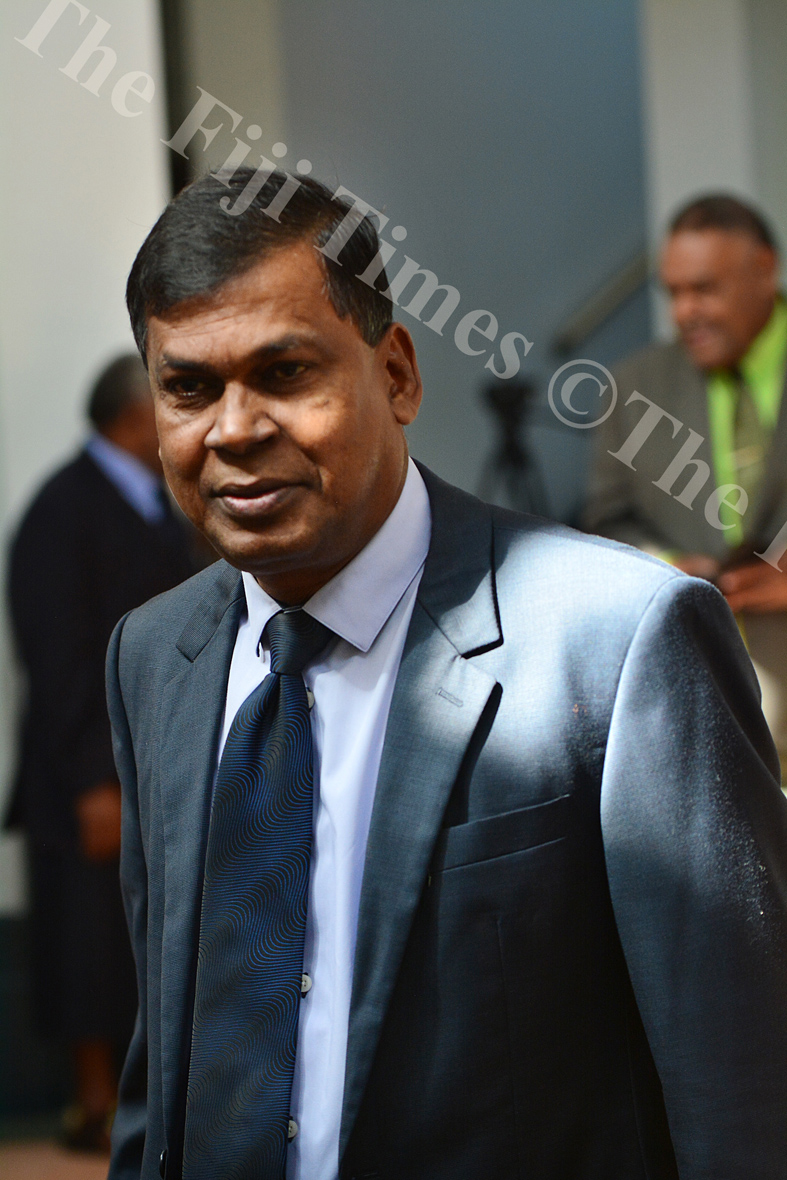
<box><xmin>107</xmin><ymin>170</ymin><xmax>787</xmax><ymax>1180</ymax></box>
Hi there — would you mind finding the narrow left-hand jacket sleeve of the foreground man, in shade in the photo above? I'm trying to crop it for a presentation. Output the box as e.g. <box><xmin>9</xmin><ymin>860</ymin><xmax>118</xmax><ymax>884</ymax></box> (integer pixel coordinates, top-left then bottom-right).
<box><xmin>106</xmin><ymin>616</ymin><xmax>147</xmax><ymax>1180</ymax></box>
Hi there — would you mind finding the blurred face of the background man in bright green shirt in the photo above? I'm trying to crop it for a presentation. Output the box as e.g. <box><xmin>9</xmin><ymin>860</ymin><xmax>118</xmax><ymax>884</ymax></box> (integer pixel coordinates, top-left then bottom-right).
<box><xmin>661</xmin><ymin>229</ymin><xmax>779</xmax><ymax>369</ymax></box>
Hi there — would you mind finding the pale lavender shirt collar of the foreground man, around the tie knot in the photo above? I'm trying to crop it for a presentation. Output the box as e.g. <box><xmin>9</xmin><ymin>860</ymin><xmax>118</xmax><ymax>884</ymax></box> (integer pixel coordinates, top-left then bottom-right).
<box><xmin>243</xmin><ymin>459</ymin><xmax>432</xmax><ymax>651</ymax></box>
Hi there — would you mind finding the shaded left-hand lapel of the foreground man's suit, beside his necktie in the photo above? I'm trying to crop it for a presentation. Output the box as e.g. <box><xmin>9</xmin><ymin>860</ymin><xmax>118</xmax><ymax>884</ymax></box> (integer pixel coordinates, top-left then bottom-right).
<box><xmin>158</xmin><ymin>563</ymin><xmax>244</xmax><ymax>1127</ymax></box>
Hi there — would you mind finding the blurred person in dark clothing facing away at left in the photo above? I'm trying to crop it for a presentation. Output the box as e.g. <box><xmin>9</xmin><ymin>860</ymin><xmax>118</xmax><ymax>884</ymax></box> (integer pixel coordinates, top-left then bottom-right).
<box><xmin>7</xmin><ymin>355</ymin><xmax>197</xmax><ymax>1149</ymax></box>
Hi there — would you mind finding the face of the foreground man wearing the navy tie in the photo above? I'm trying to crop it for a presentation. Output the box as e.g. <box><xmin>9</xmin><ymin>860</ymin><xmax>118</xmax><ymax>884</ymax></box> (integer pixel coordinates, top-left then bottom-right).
<box><xmin>147</xmin><ymin>242</ymin><xmax>421</xmax><ymax>602</ymax></box>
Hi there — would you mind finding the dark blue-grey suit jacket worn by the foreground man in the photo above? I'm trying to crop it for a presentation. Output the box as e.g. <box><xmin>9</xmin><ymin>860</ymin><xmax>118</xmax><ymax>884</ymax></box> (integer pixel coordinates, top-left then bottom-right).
<box><xmin>109</xmin><ymin>472</ymin><xmax>787</xmax><ymax>1180</ymax></box>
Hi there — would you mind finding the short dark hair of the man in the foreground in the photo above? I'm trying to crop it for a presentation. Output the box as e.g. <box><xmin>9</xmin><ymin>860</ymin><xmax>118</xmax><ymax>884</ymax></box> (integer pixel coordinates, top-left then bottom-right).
<box><xmin>126</xmin><ymin>168</ymin><xmax>392</xmax><ymax>359</ymax></box>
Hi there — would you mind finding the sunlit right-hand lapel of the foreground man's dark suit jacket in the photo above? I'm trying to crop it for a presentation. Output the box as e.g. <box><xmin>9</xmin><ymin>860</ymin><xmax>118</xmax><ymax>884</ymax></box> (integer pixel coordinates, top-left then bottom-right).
<box><xmin>340</xmin><ymin>468</ymin><xmax>503</xmax><ymax>1158</ymax></box>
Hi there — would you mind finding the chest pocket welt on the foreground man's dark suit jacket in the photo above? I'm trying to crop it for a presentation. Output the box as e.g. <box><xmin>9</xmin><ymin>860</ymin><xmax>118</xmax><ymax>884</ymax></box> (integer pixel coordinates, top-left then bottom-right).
<box><xmin>429</xmin><ymin>794</ymin><xmax>572</xmax><ymax>873</ymax></box>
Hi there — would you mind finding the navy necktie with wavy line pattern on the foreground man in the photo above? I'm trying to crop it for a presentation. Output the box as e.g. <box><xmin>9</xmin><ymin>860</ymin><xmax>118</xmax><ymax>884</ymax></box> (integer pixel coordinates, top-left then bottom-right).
<box><xmin>183</xmin><ymin>609</ymin><xmax>334</xmax><ymax>1180</ymax></box>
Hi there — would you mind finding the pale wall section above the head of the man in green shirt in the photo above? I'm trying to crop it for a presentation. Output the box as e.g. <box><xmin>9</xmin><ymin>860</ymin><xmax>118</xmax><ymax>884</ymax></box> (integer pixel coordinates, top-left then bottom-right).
<box><xmin>642</xmin><ymin>0</ymin><xmax>787</xmax><ymax>334</ymax></box>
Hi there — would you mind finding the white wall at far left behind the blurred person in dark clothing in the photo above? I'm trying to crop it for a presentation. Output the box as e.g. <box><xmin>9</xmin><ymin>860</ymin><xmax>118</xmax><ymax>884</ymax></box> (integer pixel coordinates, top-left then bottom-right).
<box><xmin>0</xmin><ymin>0</ymin><xmax>168</xmax><ymax>912</ymax></box>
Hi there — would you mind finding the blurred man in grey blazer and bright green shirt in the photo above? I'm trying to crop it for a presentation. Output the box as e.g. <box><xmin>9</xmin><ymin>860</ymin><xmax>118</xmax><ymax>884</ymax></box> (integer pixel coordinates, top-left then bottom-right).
<box><xmin>584</xmin><ymin>196</ymin><xmax>787</xmax><ymax>768</ymax></box>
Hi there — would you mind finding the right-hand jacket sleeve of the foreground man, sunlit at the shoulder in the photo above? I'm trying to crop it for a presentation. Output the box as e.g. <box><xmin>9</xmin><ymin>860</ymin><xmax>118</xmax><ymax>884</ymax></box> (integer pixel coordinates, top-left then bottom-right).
<box><xmin>602</xmin><ymin>578</ymin><xmax>787</xmax><ymax>1180</ymax></box>
